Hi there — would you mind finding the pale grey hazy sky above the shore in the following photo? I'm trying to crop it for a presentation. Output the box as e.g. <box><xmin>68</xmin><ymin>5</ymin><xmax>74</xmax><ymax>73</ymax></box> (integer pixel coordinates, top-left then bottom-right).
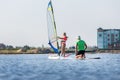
<box><xmin>0</xmin><ymin>0</ymin><xmax>120</xmax><ymax>47</ymax></box>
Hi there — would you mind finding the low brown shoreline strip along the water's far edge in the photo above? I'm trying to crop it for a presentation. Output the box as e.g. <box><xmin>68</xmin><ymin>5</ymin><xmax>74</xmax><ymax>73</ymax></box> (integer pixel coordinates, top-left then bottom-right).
<box><xmin>0</xmin><ymin>49</ymin><xmax>120</xmax><ymax>54</ymax></box>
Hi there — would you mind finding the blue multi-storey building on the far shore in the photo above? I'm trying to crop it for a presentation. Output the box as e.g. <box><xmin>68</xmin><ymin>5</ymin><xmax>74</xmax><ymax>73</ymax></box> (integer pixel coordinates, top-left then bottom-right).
<box><xmin>97</xmin><ymin>28</ymin><xmax>120</xmax><ymax>49</ymax></box>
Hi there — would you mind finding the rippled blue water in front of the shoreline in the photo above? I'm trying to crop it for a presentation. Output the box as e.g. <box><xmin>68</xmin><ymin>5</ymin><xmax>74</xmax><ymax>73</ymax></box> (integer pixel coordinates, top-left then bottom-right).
<box><xmin>0</xmin><ymin>54</ymin><xmax>120</xmax><ymax>80</ymax></box>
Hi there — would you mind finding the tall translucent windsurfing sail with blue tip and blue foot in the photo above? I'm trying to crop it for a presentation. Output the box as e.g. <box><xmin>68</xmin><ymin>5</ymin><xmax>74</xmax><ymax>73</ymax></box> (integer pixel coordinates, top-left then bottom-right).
<box><xmin>47</xmin><ymin>0</ymin><xmax>59</xmax><ymax>53</ymax></box>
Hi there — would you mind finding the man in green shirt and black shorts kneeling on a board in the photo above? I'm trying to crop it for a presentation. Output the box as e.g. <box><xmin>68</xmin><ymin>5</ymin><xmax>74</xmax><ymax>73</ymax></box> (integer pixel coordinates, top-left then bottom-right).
<box><xmin>75</xmin><ymin>36</ymin><xmax>87</xmax><ymax>59</ymax></box>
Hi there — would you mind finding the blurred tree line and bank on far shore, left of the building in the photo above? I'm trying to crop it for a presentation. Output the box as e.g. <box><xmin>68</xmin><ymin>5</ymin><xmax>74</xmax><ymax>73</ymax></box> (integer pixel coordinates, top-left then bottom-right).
<box><xmin>0</xmin><ymin>43</ymin><xmax>96</xmax><ymax>54</ymax></box>
